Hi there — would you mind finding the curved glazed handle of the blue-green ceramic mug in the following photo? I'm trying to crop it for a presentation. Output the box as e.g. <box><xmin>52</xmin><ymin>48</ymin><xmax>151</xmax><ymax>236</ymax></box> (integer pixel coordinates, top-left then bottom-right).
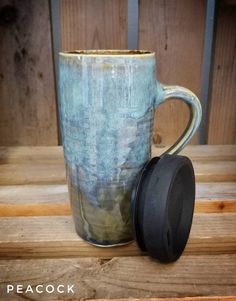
<box><xmin>155</xmin><ymin>82</ymin><xmax>202</xmax><ymax>155</ymax></box>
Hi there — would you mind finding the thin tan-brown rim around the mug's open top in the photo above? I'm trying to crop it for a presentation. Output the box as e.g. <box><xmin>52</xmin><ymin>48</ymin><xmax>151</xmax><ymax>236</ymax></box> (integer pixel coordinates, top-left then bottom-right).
<box><xmin>59</xmin><ymin>49</ymin><xmax>155</xmax><ymax>57</ymax></box>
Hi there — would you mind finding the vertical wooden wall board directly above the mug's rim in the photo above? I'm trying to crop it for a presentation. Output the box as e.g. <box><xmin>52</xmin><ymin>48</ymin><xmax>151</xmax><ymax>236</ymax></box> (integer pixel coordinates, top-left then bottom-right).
<box><xmin>61</xmin><ymin>0</ymin><xmax>127</xmax><ymax>50</ymax></box>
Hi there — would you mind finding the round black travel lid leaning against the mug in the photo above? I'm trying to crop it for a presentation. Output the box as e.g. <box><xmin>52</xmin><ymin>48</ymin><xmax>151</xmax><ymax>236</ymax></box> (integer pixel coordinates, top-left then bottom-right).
<box><xmin>132</xmin><ymin>155</ymin><xmax>195</xmax><ymax>263</ymax></box>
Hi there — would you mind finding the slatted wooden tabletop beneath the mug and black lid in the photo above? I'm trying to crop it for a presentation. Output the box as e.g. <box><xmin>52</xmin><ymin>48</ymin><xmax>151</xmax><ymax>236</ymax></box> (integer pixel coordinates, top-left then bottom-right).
<box><xmin>0</xmin><ymin>146</ymin><xmax>236</xmax><ymax>301</ymax></box>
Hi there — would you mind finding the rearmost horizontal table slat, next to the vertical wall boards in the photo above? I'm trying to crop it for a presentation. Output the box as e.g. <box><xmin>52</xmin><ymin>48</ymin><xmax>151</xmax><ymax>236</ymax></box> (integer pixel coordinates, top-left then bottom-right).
<box><xmin>0</xmin><ymin>145</ymin><xmax>236</xmax><ymax>164</ymax></box>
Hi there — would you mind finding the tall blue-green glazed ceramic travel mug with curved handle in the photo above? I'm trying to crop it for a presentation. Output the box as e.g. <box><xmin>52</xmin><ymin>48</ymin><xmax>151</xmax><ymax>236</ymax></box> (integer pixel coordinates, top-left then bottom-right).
<box><xmin>59</xmin><ymin>50</ymin><xmax>201</xmax><ymax>246</ymax></box>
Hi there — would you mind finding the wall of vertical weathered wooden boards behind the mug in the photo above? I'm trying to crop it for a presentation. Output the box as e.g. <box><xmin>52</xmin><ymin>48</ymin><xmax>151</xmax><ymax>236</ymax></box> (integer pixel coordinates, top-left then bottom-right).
<box><xmin>0</xmin><ymin>0</ymin><xmax>236</xmax><ymax>145</ymax></box>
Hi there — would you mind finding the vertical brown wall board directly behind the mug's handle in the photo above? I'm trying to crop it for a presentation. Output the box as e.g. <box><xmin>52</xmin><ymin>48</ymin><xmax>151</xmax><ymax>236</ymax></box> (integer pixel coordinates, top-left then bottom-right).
<box><xmin>139</xmin><ymin>0</ymin><xmax>206</xmax><ymax>145</ymax></box>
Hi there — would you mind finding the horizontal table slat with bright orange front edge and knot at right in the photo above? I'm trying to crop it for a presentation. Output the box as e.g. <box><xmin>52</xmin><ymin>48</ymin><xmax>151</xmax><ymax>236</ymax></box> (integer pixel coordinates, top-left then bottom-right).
<box><xmin>0</xmin><ymin>182</ymin><xmax>236</xmax><ymax>217</ymax></box>
